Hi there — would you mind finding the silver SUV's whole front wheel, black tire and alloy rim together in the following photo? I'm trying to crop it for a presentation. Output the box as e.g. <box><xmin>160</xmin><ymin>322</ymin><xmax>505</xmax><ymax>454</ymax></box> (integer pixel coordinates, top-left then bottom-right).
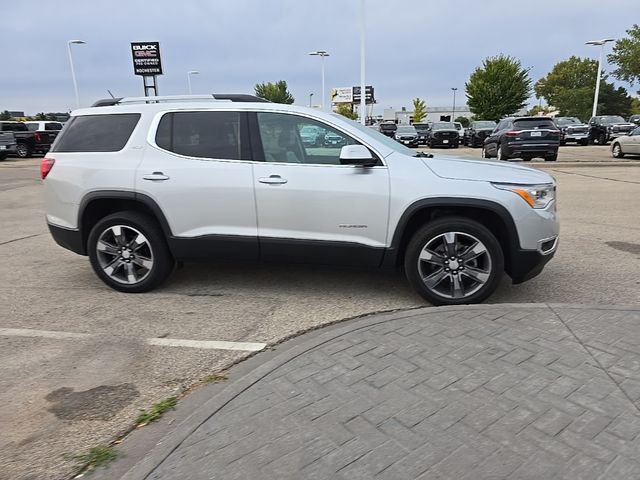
<box><xmin>404</xmin><ymin>217</ymin><xmax>504</xmax><ymax>305</ymax></box>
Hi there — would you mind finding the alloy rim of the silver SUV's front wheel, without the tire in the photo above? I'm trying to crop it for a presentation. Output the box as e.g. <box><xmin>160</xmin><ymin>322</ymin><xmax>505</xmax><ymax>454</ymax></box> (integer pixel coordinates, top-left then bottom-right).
<box><xmin>418</xmin><ymin>232</ymin><xmax>492</xmax><ymax>299</ymax></box>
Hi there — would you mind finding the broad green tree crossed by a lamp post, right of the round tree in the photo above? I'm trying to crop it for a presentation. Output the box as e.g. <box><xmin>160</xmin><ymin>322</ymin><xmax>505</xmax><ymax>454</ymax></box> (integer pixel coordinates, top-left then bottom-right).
<box><xmin>534</xmin><ymin>56</ymin><xmax>631</xmax><ymax>121</ymax></box>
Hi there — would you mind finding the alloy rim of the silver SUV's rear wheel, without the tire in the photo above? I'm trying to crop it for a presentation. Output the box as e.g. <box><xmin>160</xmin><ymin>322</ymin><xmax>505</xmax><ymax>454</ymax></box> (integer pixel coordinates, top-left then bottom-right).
<box><xmin>96</xmin><ymin>225</ymin><xmax>154</xmax><ymax>285</ymax></box>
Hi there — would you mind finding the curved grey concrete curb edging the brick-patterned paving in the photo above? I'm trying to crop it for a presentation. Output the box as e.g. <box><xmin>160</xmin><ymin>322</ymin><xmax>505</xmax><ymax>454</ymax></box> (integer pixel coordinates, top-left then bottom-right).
<box><xmin>121</xmin><ymin>303</ymin><xmax>640</xmax><ymax>480</ymax></box>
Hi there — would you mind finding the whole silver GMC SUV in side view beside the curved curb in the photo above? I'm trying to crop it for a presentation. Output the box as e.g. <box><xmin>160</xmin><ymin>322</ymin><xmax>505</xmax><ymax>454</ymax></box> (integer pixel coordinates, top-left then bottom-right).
<box><xmin>41</xmin><ymin>95</ymin><xmax>559</xmax><ymax>304</ymax></box>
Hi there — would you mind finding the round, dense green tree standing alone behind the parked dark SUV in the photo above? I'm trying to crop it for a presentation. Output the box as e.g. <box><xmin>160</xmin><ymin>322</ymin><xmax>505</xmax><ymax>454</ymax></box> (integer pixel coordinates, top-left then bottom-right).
<box><xmin>464</xmin><ymin>55</ymin><xmax>531</xmax><ymax>120</ymax></box>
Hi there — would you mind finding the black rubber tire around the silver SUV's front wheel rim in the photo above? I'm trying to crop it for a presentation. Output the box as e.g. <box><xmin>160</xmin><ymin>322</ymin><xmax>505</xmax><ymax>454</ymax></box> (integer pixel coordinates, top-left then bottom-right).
<box><xmin>404</xmin><ymin>217</ymin><xmax>504</xmax><ymax>305</ymax></box>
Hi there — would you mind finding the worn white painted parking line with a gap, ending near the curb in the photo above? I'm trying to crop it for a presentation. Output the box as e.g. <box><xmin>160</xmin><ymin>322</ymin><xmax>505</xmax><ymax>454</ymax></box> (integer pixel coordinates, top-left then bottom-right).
<box><xmin>0</xmin><ymin>328</ymin><xmax>267</xmax><ymax>352</ymax></box>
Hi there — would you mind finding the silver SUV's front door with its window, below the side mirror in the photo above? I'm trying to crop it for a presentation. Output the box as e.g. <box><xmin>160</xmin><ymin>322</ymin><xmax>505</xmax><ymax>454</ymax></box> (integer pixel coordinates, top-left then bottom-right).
<box><xmin>252</xmin><ymin>112</ymin><xmax>389</xmax><ymax>266</ymax></box>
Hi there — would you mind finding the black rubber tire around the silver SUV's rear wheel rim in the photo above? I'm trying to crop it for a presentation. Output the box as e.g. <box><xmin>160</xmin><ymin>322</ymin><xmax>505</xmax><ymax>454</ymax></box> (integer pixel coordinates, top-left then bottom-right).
<box><xmin>87</xmin><ymin>211</ymin><xmax>175</xmax><ymax>293</ymax></box>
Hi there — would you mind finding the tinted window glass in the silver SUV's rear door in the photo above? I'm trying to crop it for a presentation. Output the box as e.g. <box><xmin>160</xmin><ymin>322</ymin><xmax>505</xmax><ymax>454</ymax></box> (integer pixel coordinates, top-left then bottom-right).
<box><xmin>156</xmin><ymin>112</ymin><xmax>242</xmax><ymax>160</ymax></box>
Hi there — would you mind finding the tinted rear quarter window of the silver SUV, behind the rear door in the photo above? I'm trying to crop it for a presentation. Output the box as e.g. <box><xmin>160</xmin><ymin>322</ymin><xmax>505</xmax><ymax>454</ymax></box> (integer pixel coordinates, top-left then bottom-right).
<box><xmin>51</xmin><ymin>113</ymin><xmax>140</xmax><ymax>152</ymax></box>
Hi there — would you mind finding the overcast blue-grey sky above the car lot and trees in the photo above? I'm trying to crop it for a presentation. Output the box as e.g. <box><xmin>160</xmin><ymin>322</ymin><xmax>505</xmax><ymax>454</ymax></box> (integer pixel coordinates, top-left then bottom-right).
<box><xmin>0</xmin><ymin>0</ymin><xmax>639</xmax><ymax>115</ymax></box>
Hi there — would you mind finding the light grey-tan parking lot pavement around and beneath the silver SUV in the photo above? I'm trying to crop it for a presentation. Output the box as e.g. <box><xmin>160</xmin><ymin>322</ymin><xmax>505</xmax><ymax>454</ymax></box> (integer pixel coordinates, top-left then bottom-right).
<box><xmin>0</xmin><ymin>146</ymin><xmax>640</xmax><ymax>479</ymax></box>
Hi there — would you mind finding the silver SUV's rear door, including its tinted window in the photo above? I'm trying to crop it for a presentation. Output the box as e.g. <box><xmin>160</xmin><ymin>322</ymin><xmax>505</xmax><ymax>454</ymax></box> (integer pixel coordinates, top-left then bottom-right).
<box><xmin>135</xmin><ymin>110</ymin><xmax>258</xmax><ymax>260</ymax></box>
